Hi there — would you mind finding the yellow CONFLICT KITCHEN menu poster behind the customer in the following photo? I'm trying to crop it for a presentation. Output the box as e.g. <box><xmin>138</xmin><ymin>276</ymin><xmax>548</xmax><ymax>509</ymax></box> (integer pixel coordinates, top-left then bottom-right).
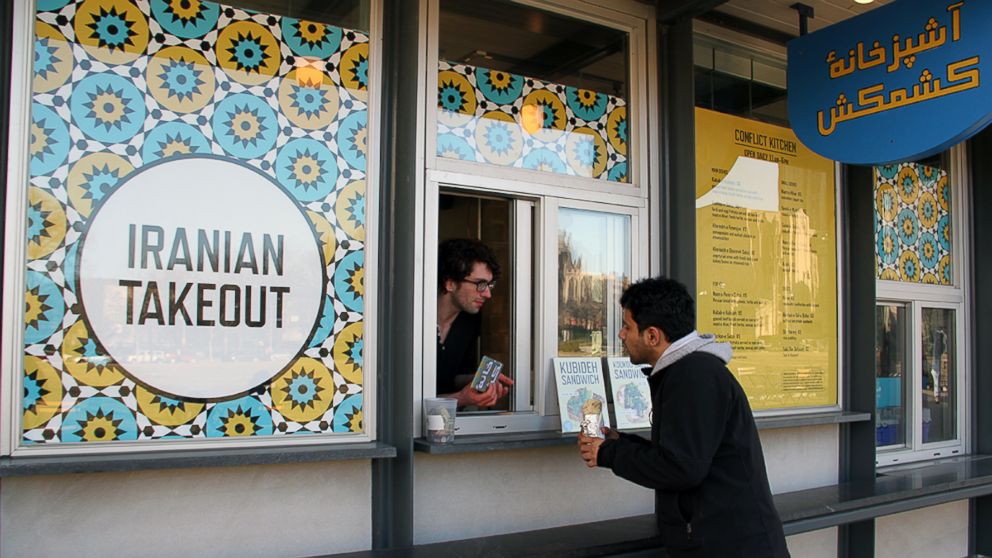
<box><xmin>696</xmin><ymin>109</ymin><xmax>837</xmax><ymax>410</ymax></box>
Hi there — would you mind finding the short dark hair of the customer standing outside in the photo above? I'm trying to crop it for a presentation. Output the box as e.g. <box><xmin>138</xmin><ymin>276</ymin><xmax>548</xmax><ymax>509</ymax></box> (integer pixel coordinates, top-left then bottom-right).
<box><xmin>620</xmin><ymin>277</ymin><xmax>696</xmax><ymax>343</ymax></box>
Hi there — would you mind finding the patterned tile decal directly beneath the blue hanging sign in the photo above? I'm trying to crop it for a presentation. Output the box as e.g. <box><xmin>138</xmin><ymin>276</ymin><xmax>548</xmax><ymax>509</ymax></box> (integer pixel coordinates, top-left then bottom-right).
<box><xmin>874</xmin><ymin>163</ymin><xmax>954</xmax><ymax>285</ymax></box>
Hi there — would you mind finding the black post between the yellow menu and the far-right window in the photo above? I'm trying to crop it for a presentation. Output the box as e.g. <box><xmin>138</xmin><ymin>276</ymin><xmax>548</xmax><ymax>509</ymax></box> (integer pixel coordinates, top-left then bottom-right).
<box><xmin>837</xmin><ymin>165</ymin><xmax>875</xmax><ymax>558</ymax></box>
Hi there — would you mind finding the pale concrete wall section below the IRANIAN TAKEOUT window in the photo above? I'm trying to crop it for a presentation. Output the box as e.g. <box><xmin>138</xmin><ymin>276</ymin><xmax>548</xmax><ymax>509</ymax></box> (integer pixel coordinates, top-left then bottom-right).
<box><xmin>0</xmin><ymin>461</ymin><xmax>372</xmax><ymax>558</ymax></box>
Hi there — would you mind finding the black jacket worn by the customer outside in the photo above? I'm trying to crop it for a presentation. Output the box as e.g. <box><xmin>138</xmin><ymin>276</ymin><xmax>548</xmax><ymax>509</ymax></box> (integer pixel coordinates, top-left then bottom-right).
<box><xmin>597</xmin><ymin>351</ymin><xmax>789</xmax><ymax>558</ymax></box>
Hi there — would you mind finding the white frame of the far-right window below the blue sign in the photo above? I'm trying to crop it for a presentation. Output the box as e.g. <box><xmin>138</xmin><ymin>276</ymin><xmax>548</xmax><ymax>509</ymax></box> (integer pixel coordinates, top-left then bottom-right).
<box><xmin>873</xmin><ymin>144</ymin><xmax>973</xmax><ymax>467</ymax></box>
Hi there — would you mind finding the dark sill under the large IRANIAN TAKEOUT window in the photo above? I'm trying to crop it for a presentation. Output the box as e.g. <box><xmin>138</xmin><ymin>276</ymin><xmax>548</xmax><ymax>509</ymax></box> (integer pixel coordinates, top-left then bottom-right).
<box><xmin>0</xmin><ymin>442</ymin><xmax>396</xmax><ymax>478</ymax></box>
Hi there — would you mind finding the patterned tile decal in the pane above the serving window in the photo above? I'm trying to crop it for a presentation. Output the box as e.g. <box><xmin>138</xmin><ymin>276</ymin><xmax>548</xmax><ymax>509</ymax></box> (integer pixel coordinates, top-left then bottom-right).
<box><xmin>437</xmin><ymin>61</ymin><xmax>630</xmax><ymax>182</ymax></box>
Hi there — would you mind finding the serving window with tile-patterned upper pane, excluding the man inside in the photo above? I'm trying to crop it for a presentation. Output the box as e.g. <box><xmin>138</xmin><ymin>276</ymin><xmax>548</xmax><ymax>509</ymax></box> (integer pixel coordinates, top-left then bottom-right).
<box><xmin>422</xmin><ymin>0</ymin><xmax>651</xmax><ymax>434</ymax></box>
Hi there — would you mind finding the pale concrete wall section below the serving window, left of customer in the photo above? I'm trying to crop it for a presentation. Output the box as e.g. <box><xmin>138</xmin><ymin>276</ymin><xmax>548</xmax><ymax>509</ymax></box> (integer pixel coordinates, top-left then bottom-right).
<box><xmin>413</xmin><ymin>445</ymin><xmax>654</xmax><ymax>544</ymax></box>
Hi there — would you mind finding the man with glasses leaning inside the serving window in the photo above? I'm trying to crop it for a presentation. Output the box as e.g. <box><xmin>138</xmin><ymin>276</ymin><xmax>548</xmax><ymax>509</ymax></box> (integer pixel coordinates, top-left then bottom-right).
<box><xmin>437</xmin><ymin>238</ymin><xmax>513</xmax><ymax>408</ymax></box>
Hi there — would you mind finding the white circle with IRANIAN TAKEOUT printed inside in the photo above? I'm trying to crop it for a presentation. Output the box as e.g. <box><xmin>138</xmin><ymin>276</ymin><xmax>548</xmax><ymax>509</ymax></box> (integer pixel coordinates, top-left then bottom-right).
<box><xmin>79</xmin><ymin>157</ymin><xmax>325</xmax><ymax>399</ymax></box>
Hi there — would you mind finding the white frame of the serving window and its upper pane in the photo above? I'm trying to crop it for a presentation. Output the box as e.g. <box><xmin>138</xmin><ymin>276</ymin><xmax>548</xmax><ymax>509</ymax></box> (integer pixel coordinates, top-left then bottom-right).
<box><xmin>413</xmin><ymin>0</ymin><xmax>660</xmax><ymax>437</ymax></box>
